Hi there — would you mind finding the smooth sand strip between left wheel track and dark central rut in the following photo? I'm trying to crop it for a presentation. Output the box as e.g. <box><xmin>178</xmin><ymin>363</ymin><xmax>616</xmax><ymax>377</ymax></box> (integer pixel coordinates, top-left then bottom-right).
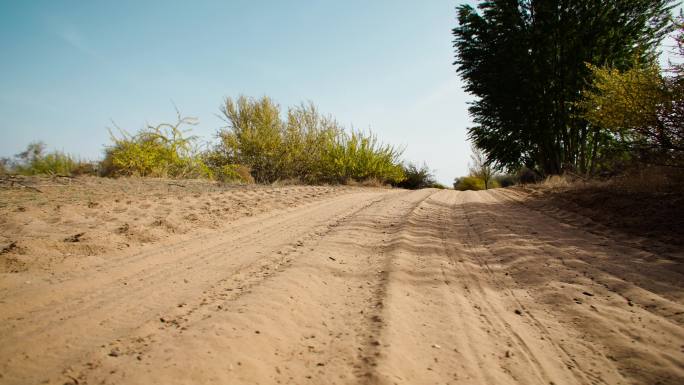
<box><xmin>70</xmin><ymin>191</ymin><xmax>431</xmax><ymax>384</ymax></box>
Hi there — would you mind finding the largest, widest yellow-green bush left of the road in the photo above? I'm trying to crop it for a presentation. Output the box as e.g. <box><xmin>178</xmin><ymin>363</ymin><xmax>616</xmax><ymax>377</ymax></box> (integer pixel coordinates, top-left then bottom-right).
<box><xmin>216</xmin><ymin>96</ymin><xmax>404</xmax><ymax>183</ymax></box>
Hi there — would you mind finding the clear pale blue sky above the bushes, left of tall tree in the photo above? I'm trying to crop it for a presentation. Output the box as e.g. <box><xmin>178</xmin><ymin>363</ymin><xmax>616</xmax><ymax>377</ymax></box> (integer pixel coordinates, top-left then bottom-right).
<box><xmin>0</xmin><ymin>0</ymin><xmax>470</xmax><ymax>183</ymax></box>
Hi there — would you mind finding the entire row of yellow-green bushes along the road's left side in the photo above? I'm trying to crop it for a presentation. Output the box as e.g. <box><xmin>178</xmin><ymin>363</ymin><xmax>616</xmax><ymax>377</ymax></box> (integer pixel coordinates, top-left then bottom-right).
<box><xmin>0</xmin><ymin>96</ymin><xmax>420</xmax><ymax>188</ymax></box>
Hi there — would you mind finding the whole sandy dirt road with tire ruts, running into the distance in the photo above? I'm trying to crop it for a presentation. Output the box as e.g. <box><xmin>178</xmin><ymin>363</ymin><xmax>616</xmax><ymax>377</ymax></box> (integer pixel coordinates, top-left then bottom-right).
<box><xmin>0</xmin><ymin>189</ymin><xmax>684</xmax><ymax>385</ymax></box>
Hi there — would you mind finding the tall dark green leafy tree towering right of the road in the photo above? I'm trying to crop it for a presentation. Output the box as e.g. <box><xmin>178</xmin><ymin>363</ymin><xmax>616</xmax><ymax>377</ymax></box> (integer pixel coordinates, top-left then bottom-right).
<box><xmin>453</xmin><ymin>0</ymin><xmax>673</xmax><ymax>174</ymax></box>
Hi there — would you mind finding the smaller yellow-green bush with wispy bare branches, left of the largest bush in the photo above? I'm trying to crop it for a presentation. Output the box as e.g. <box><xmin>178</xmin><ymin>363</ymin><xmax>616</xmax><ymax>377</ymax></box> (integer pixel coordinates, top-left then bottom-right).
<box><xmin>101</xmin><ymin>114</ymin><xmax>213</xmax><ymax>178</ymax></box>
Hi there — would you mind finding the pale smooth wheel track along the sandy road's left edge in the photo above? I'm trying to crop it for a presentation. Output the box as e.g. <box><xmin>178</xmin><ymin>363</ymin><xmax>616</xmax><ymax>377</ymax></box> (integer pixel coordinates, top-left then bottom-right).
<box><xmin>0</xmin><ymin>189</ymin><xmax>391</xmax><ymax>384</ymax></box>
